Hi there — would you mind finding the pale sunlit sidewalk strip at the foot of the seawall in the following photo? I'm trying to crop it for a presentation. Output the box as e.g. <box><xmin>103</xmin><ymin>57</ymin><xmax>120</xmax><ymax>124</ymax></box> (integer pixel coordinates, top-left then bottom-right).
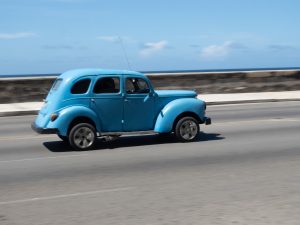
<box><xmin>0</xmin><ymin>91</ymin><xmax>300</xmax><ymax>116</ymax></box>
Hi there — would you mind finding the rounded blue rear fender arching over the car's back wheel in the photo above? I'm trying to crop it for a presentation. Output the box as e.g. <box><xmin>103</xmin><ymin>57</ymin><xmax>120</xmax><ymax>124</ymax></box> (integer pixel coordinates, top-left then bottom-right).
<box><xmin>47</xmin><ymin>105</ymin><xmax>100</xmax><ymax>136</ymax></box>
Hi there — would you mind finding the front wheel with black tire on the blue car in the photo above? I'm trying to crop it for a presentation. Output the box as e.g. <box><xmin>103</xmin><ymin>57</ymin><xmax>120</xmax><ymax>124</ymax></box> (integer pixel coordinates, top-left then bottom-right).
<box><xmin>174</xmin><ymin>116</ymin><xmax>200</xmax><ymax>142</ymax></box>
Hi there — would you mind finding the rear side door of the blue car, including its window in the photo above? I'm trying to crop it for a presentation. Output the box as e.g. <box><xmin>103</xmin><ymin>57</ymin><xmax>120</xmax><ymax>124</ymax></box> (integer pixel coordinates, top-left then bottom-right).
<box><xmin>91</xmin><ymin>75</ymin><xmax>124</xmax><ymax>132</ymax></box>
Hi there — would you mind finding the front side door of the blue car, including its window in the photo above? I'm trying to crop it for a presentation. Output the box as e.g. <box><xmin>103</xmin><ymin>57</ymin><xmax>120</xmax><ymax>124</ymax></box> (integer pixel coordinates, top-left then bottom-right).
<box><xmin>123</xmin><ymin>76</ymin><xmax>154</xmax><ymax>131</ymax></box>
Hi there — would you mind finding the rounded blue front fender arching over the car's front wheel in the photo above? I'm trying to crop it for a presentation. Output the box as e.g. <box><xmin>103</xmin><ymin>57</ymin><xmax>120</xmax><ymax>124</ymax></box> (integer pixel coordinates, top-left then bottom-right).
<box><xmin>154</xmin><ymin>98</ymin><xmax>205</xmax><ymax>133</ymax></box>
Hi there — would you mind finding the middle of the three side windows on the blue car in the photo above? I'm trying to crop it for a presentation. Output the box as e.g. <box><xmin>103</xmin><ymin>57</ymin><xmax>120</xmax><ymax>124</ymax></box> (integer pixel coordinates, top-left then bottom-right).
<box><xmin>94</xmin><ymin>77</ymin><xmax>120</xmax><ymax>94</ymax></box>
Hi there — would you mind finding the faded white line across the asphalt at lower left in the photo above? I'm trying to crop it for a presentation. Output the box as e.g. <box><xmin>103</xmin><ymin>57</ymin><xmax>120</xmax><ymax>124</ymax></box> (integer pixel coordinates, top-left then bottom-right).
<box><xmin>0</xmin><ymin>187</ymin><xmax>134</xmax><ymax>205</ymax></box>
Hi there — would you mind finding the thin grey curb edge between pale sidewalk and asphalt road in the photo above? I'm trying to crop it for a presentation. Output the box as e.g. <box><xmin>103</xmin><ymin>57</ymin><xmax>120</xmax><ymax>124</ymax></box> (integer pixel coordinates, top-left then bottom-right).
<box><xmin>0</xmin><ymin>98</ymin><xmax>300</xmax><ymax>117</ymax></box>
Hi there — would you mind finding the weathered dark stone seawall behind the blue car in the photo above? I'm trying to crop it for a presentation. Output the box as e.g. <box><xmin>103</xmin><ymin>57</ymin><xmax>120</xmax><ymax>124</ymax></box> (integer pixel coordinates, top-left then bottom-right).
<box><xmin>0</xmin><ymin>70</ymin><xmax>300</xmax><ymax>104</ymax></box>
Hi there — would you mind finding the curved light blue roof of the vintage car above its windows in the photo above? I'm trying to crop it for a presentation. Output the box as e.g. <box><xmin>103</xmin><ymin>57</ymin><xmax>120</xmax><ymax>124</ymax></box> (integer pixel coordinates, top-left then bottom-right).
<box><xmin>59</xmin><ymin>68</ymin><xmax>144</xmax><ymax>79</ymax></box>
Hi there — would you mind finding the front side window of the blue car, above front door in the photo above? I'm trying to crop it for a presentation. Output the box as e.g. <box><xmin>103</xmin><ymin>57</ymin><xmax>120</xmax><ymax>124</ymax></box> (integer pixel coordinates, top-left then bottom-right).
<box><xmin>126</xmin><ymin>78</ymin><xmax>150</xmax><ymax>94</ymax></box>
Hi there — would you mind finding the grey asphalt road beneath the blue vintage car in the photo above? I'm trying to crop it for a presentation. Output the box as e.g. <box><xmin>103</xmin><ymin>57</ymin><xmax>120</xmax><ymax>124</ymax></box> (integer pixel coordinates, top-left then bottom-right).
<box><xmin>0</xmin><ymin>102</ymin><xmax>300</xmax><ymax>225</ymax></box>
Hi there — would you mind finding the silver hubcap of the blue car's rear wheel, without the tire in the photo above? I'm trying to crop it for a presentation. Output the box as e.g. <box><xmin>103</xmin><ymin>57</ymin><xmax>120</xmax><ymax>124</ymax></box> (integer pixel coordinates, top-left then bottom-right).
<box><xmin>74</xmin><ymin>127</ymin><xmax>95</xmax><ymax>148</ymax></box>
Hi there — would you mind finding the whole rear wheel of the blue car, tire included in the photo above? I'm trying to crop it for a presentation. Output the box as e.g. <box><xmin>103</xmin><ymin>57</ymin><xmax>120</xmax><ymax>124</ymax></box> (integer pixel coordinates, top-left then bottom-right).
<box><xmin>69</xmin><ymin>123</ymin><xmax>97</xmax><ymax>151</ymax></box>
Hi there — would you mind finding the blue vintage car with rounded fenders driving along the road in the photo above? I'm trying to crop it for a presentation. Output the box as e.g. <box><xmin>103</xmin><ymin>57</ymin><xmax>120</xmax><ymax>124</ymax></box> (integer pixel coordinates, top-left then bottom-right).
<box><xmin>32</xmin><ymin>69</ymin><xmax>211</xmax><ymax>150</ymax></box>
